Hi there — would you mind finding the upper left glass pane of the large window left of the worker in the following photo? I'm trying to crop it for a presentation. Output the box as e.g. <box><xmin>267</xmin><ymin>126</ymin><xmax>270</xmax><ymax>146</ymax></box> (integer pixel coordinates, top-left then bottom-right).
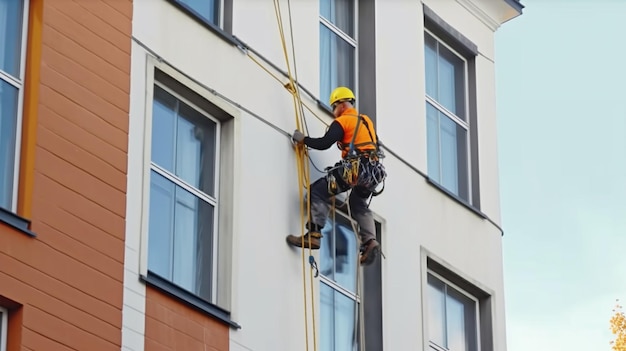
<box><xmin>152</xmin><ymin>86</ymin><xmax>178</xmax><ymax>173</ymax></box>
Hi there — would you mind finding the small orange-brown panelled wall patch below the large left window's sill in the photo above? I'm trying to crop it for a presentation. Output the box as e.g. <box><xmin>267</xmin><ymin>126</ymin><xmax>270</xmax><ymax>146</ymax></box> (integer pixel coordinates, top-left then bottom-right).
<box><xmin>145</xmin><ymin>288</ymin><xmax>228</xmax><ymax>351</ymax></box>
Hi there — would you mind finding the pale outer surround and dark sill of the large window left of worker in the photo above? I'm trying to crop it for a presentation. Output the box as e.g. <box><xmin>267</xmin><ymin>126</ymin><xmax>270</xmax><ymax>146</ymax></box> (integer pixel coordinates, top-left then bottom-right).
<box><xmin>138</xmin><ymin>54</ymin><xmax>241</xmax><ymax>329</ymax></box>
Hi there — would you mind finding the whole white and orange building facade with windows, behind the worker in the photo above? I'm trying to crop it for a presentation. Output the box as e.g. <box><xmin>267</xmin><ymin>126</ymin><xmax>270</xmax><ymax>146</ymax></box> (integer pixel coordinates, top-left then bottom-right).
<box><xmin>0</xmin><ymin>0</ymin><xmax>522</xmax><ymax>351</ymax></box>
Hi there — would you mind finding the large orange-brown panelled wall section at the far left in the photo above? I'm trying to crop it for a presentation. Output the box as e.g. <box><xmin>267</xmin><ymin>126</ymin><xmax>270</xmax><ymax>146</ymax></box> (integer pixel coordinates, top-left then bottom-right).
<box><xmin>0</xmin><ymin>0</ymin><xmax>132</xmax><ymax>351</ymax></box>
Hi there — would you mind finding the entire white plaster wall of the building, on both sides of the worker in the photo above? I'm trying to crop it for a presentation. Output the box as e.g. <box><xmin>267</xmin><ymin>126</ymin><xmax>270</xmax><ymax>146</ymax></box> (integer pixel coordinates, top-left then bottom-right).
<box><xmin>124</xmin><ymin>0</ymin><xmax>506</xmax><ymax>351</ymax></box>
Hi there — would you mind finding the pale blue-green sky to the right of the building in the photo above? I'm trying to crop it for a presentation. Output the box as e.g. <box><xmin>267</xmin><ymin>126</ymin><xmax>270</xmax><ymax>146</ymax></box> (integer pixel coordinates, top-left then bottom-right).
<box><xmin>496</xmin><ymin>0</ymin><xmax>626</xmax><ymax>351</ymax></box>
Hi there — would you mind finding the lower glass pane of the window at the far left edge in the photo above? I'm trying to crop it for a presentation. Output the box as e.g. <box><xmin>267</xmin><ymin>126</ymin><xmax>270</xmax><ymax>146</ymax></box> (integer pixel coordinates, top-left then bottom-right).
<box><xmin>0</xmin><ymin>78</ymin><xmax>18</xmax><ymax>210</ymax></box>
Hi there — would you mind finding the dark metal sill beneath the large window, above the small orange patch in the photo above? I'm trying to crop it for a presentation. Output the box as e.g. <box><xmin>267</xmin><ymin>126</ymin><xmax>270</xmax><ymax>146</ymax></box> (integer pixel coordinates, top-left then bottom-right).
<box><xmin>140</xmin><ymin>272</ymin><xmax>241</xmax><ymax>329</ymax></box>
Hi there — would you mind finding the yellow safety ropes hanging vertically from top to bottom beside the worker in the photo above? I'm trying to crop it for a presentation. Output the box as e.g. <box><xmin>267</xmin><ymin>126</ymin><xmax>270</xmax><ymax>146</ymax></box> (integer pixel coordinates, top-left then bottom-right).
<box><xmin>270</xmin><ymin>0</ymin><xmax>317</xmax><ymax>351</ymax></box>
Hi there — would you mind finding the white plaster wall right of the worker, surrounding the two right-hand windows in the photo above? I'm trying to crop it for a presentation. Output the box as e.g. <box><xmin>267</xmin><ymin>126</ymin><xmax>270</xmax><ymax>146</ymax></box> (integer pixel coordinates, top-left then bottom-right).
<box><xmin>371</xmin><ymin>0</ymin><xmax>506</xmax><ymax>350</ymax></box>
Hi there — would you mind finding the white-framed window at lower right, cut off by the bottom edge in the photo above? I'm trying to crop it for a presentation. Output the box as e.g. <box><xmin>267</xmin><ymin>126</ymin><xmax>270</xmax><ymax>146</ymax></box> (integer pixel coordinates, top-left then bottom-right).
<box><xmin>427</xmin><ymin>272</ymin><xmax>478</xmax><ymax>351</ymax></box>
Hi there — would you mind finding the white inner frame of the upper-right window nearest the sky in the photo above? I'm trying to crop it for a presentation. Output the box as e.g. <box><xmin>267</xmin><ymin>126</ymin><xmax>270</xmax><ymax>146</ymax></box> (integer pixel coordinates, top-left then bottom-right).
<box><xmin>424</xmin><ymin>28</ymin><xmax>473</xmax><ymax>204</ymax></box>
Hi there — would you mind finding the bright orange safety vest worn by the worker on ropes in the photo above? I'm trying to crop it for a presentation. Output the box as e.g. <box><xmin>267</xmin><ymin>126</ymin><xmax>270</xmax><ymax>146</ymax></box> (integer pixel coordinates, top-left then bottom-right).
<box><xmin>335</xmin><ymin>108</ymin><xmax>378</xmax><ymax>158</ymax></box>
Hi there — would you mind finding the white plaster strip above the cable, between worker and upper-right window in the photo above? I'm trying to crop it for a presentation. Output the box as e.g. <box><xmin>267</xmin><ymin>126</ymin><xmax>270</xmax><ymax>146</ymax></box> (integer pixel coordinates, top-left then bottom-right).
<box><xmin>372</xmin><ymin>0</ymin><xmax>426</xmax><ymax>170</ymax></box>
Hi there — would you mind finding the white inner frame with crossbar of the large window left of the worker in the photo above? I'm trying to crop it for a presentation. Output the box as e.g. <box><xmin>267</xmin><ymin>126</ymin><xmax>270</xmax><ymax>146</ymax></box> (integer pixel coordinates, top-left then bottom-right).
<box><xmin>147</xmin><ymin>79</ymin><xmax>221</xmax><ymax>303</ymax></box>
